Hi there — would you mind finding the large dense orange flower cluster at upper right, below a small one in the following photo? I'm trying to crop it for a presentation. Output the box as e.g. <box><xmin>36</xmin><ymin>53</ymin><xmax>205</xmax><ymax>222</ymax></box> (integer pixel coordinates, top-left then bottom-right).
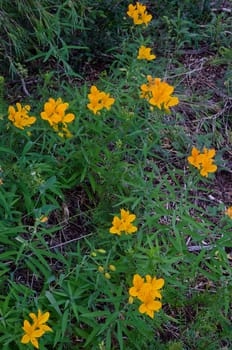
<box><xmin>140</xmin><ymin>75</ymin><xmax>179</xmax><ymax>112</ymax></box>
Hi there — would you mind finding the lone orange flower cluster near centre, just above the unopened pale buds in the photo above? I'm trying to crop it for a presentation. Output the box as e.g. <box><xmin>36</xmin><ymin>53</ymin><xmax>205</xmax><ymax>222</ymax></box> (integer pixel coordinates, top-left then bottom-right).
<box><xmin>110</xmin><ymin>209</ymin><xmax>137</xmax><ymax>236</ymax></box>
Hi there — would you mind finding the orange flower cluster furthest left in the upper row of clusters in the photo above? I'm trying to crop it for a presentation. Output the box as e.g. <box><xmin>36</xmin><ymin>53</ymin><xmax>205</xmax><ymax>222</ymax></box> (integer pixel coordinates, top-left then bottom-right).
<box><xmin>8</xmin><ymin>103</ymin><xmax>36</xmax><ymax>130</ymax></box>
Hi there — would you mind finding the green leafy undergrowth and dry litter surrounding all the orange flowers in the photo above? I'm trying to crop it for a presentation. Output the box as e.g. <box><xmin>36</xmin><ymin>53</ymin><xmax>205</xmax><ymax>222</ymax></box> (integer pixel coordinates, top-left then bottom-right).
<box><xmin>0</xmin><ymin>0</ymin><xmax>232</xmax><ymax>350</ymax></box>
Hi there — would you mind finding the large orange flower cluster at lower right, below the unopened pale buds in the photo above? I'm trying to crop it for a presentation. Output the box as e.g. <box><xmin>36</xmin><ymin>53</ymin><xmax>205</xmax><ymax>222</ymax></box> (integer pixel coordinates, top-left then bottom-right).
<box><xmin>129</xmin><ymin>274</ymin><xmax>164</xmax><ymax>318</ymax></box>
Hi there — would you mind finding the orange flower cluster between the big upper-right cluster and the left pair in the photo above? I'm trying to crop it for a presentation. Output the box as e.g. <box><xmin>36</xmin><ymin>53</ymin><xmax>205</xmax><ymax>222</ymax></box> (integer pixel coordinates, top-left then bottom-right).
<box><xmin>87</xmin><ymin>85</ymin><xmax>115</xmax><ymax>114</ymax></box>
